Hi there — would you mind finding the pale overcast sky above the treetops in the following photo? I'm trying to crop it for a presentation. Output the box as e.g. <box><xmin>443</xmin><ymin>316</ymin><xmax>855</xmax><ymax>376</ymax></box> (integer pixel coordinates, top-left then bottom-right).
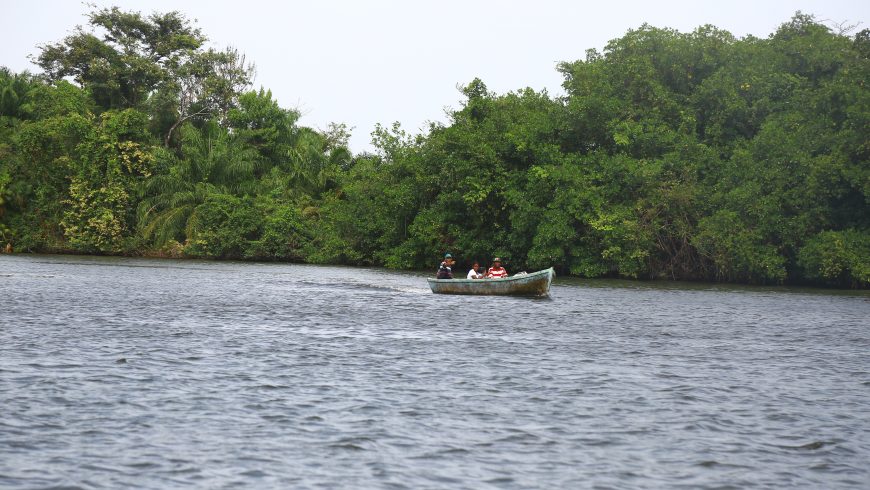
<box><xmin>0</xmin><ymin>0</ymin><xmax>870</xmax><ymax>151</ymax></box>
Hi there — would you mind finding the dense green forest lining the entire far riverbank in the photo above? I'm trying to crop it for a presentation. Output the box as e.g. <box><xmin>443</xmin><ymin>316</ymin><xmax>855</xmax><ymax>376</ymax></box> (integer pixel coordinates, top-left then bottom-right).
<box><xmin>0</xmin><ymin>8</ymin><xmax>870</xmax><ymax>288</ymax></box>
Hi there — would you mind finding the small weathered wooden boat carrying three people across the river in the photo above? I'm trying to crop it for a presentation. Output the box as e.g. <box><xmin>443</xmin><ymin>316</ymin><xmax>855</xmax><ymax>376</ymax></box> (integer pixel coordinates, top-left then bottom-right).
<box><xmin>428</xmin><ymin>267</ymin><xmax>556</xmax><ymax>296</ymax></box>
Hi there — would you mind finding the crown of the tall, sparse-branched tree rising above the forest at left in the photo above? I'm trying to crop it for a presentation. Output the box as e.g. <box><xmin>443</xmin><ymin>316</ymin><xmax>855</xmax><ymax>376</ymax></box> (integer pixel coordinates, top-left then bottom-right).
<box><xmin>37</xmin><ymin>7</ymin><xmax>254</xmax><ymax>146</ymax></box>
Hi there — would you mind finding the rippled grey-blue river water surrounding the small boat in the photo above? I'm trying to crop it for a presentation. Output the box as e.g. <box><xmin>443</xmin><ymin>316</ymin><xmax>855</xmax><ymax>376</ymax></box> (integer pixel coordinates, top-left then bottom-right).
<box><xmin>0</xmin><ymin>255</ymin><xmax>870</xmax><ymax>489</ymax></box>
